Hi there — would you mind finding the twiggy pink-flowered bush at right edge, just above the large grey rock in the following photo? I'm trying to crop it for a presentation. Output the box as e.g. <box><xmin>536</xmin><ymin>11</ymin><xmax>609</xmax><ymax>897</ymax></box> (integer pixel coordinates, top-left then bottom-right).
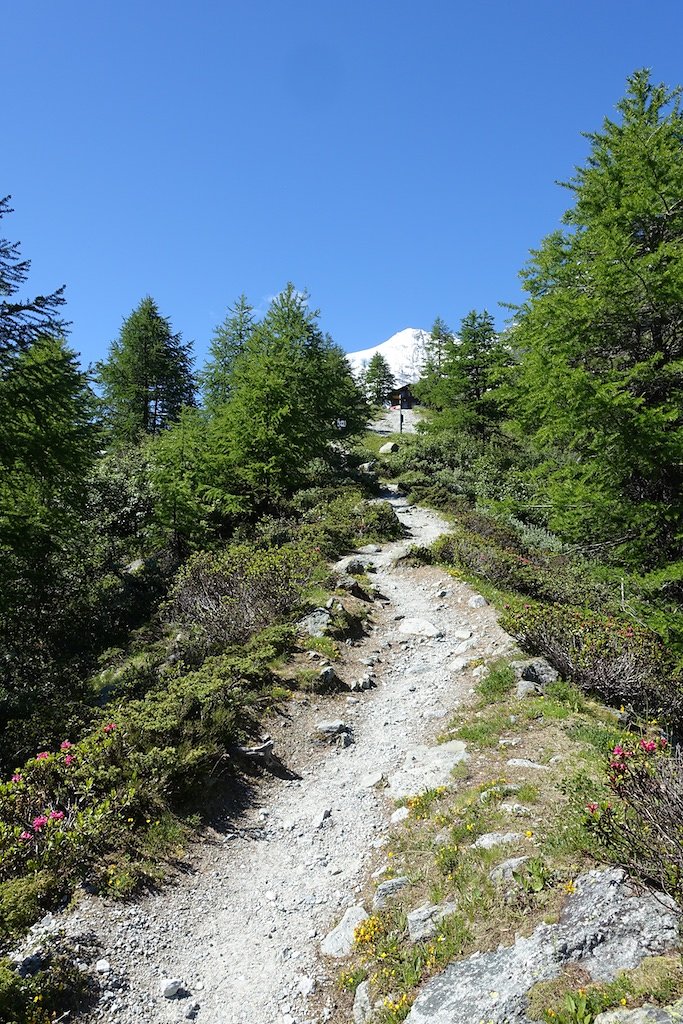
<box><xmin>587</xmin><ymin>736</ymin><xmax>683</xmax><ymax>908</ymax></box>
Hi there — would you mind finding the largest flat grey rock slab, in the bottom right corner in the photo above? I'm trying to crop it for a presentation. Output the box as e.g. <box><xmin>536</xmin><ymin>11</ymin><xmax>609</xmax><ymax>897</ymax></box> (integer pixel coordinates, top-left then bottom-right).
<box><xmin>407</xmin><ymin>868</ymin><xmax>679</xmax><ymax>1024</ymax></box>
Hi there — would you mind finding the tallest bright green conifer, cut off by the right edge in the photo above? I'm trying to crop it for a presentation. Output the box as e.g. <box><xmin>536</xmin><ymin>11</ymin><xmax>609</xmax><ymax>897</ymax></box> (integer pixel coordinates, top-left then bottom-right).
<box><xmin>512</xmin><ymin>71</ymin><xmax>683</xmax><ymax>559</ymax></box>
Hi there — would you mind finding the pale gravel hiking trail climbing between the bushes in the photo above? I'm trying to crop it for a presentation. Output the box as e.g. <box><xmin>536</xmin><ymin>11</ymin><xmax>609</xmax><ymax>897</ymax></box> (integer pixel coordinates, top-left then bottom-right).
<box><xmin>58</xmin><ymin>493</ymin><xmax>512</xmax><ymax>1024</ymax></box>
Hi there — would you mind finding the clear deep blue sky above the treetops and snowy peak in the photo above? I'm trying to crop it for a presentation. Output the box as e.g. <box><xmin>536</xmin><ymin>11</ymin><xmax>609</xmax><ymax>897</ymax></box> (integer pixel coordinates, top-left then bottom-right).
<box><xmin>5</xmin><ymin>0</ymin><xmax>683</xmax><ymax>362</ymax></box>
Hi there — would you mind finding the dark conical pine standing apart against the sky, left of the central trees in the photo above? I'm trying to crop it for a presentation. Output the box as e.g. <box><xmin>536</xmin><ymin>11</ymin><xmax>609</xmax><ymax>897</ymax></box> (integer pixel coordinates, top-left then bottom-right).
<box><xmin>97</xmin><ymin>296</ymin><xmax>195</xmax><ymax>441</ymax></box>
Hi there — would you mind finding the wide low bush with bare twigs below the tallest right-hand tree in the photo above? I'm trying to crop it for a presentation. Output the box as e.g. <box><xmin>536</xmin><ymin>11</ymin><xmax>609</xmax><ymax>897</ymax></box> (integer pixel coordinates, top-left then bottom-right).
<box><xmin>501</xmin><ymin>602</ymin><xmax>683</xmax><ymax>727</ymax></box>
